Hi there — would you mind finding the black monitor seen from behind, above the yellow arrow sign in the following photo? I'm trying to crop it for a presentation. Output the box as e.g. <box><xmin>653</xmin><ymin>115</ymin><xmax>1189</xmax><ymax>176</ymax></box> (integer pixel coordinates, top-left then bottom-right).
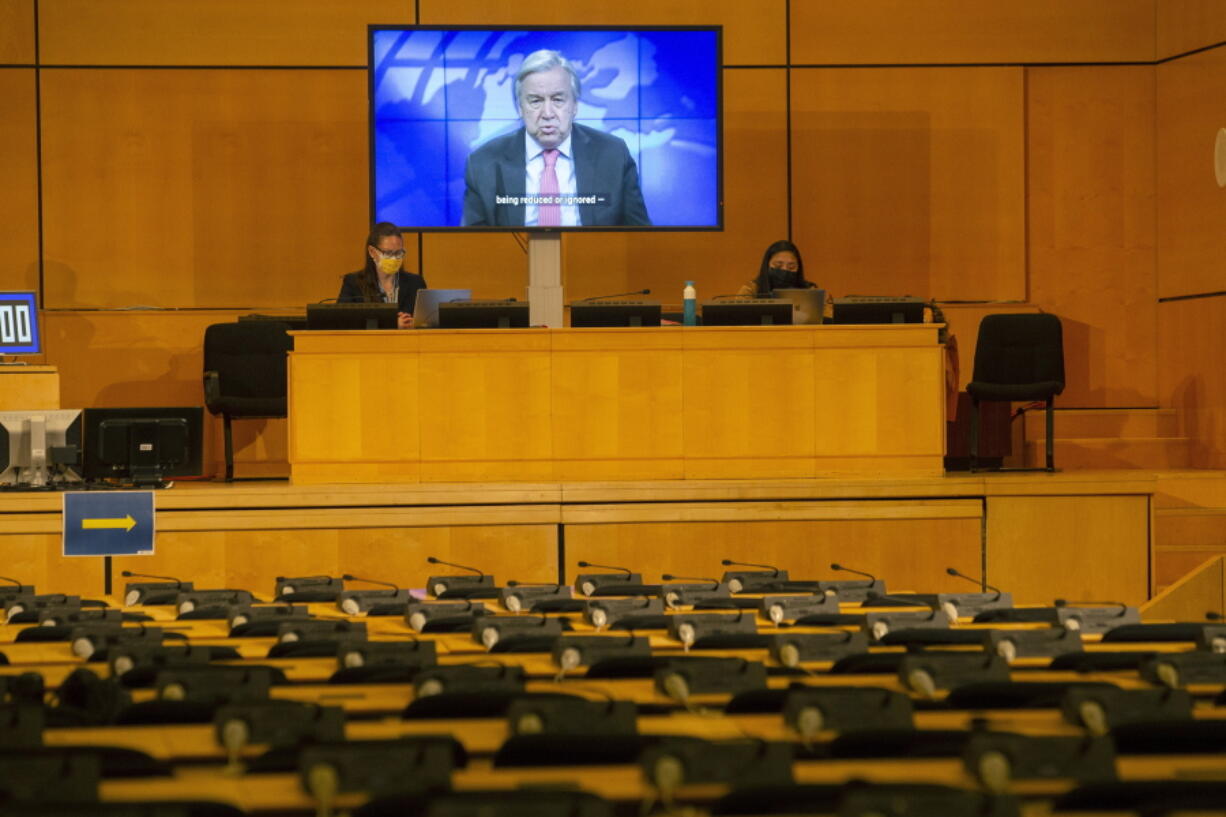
<box><xmin>83</xmin><ymin>406</ymin><xmax>205</xmax><ymax>486</ymax></box>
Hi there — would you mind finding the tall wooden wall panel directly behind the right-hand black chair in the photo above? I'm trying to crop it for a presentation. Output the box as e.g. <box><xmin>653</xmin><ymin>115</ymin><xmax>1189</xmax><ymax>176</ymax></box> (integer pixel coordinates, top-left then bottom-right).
<box><xmin>1026</xmin><ymin>66</ymin><xmax>1157</xmax><ymax>407</ymax></box>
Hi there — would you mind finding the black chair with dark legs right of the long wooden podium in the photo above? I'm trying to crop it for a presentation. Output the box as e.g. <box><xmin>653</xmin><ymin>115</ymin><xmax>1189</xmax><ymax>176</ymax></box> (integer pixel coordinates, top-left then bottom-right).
<box><xmin>966</xmin><ymin>313</ymin><xmax>1064</xmax><ymax>471</ymax></box>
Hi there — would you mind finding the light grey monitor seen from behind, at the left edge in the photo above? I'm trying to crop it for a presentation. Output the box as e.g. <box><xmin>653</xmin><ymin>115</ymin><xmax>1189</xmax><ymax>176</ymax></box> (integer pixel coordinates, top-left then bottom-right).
<box><xmin>0</xmin><ymin>409</ymin><xmax>81</xmax><ymax>488</ymax></box>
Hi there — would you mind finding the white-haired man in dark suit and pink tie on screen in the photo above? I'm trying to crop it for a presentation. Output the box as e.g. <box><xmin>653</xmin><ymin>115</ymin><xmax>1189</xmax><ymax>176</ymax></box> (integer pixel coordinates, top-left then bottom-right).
<box><xmin>463</xmin><ymin>50</ymin><xmax>651</xmax><ymax>227</ymax></box>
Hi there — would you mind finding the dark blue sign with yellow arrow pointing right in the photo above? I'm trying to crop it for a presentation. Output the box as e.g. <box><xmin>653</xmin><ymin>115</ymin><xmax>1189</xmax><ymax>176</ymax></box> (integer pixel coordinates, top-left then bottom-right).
<box><xmin>64</xmin><ymin>491</ymin><xmax>154</xmax><ymax>556</ymax></box>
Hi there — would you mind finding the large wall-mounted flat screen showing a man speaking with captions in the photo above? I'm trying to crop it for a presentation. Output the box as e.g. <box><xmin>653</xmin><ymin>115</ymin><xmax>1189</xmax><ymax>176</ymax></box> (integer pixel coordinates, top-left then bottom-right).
<box><xmin>369</xmin><ymin>26</ymin><xmax>723</xmax><ymax>231</ymax></box>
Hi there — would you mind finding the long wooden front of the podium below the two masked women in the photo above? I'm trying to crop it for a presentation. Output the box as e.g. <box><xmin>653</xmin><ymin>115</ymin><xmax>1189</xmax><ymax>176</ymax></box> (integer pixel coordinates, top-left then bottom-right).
<box><xmin>289</xmin><ymin>324</ymin><xmax>945</xmax><ymax>485</ymax></box>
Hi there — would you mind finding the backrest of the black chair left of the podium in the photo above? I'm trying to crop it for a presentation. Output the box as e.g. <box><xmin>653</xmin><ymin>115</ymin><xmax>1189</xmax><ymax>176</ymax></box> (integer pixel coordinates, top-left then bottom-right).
<box><xmin>205</xmin><ymin>320</ymin><xmax>294</xmax><ymax>397</ymax></box>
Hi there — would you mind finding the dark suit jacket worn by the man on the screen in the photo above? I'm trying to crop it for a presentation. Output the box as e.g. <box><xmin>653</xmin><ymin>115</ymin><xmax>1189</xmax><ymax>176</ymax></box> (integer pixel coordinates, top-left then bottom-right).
<box><xmin>463</xmin><ymin>124</ymin><xmax>651</xmax><ymax>227</ymax></box>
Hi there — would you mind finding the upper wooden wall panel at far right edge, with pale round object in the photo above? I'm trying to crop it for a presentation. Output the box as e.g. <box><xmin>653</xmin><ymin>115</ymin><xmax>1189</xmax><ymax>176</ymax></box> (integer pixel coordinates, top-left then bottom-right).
<box><xmin>1155</xmin><ymin>47</ymin><xmax>1226</xmax><ymax>297</ymax></box>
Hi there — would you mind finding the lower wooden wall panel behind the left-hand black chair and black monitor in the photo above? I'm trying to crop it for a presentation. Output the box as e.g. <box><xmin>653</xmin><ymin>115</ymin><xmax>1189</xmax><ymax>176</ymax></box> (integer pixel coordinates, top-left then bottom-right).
<box><xmin>43</xmin><ymin>310</ymin><xmax>288</xmax><ymax>476</ymax></box>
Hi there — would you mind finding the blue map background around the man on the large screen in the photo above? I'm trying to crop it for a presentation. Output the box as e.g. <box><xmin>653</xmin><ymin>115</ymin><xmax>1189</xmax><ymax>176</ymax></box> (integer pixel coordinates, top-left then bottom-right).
<box><xmin>370</xmin><ymin>28</ymin><xmax>720</xmax><ymax>228</ymax></box>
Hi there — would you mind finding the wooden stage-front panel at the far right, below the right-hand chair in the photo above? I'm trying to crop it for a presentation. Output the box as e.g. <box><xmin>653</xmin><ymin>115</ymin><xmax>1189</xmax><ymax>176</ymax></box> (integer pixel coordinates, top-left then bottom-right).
<box><xmin>987</xmin><ymin>496</ymin><xmax>1150</xmax><ymax>605</ymax></box>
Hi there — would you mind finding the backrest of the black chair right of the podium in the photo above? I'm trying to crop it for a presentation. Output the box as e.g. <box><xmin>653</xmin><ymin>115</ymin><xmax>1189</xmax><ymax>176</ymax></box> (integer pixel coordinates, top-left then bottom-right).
<box><xmin>972</xmin><ymin>313</ymin><xmax>1064</xmax><ymax>389</ymax></box>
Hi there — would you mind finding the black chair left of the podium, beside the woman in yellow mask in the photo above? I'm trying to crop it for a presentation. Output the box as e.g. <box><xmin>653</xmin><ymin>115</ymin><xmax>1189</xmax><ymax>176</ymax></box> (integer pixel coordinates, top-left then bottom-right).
<box><xmin>205</xmin><ymin>320</ymin><xmax>293</xmax><ymax>482</ymax></box>
